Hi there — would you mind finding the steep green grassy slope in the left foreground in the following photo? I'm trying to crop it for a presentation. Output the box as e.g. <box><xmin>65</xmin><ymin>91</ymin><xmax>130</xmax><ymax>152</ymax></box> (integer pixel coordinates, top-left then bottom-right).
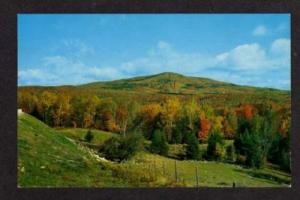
<box><xmin>18</xmin><ymin>114</ymin><xmax>130</xmax><ymax>187</ymax></box>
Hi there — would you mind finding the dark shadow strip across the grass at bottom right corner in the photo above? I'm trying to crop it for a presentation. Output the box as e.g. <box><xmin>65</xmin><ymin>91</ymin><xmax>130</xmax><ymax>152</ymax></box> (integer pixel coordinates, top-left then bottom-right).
<box><xmin>235</xmin><ymin>169</ymin><xmax>291</xmax><ymax>185</ymax></box>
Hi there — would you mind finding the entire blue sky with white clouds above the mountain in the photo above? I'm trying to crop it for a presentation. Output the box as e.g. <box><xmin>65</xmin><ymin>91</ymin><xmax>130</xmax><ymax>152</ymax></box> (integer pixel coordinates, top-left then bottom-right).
<box><xmin>18</xmin><ymin>14</ymin><xmax>291</xmax><ymax>90</ymax></box>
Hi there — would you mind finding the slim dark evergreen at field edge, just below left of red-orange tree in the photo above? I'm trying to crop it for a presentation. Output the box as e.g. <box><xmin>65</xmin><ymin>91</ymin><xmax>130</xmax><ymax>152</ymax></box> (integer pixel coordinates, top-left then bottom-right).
<box><xmin>186</xmin><ymin>133</ymin><xmax>200</xmax><ymax>160</ymax></box>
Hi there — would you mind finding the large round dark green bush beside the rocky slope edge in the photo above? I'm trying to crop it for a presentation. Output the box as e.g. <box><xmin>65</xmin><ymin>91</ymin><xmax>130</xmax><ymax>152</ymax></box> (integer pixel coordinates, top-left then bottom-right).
<box><xmin>100</xmin><ymin>134</ymin><xmax>142</xmax><ymax>162</ymax></box>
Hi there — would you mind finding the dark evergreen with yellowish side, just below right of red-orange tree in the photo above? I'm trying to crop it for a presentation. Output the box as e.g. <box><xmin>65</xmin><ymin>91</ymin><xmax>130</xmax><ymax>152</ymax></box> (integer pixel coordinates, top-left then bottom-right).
<box><xmin>207</xmin><ymin>130</ymin><xmax>225</xmax><ymax>160</ymax></box>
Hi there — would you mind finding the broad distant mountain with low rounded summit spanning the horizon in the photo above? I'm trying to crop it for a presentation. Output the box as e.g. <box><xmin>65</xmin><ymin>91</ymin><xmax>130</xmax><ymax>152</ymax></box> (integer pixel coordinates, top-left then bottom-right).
<box><xmin>19</xmin><ymin>72</ymin><xmax>290</xmax><ymax>104</ymax></box>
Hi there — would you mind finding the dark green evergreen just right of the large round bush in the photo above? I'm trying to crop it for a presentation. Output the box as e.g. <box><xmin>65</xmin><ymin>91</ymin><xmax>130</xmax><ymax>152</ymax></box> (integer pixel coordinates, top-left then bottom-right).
<box><xmin>150</xmin><ymin>129</ymin><xmax>169</xmax><ymax>155</ymax></box>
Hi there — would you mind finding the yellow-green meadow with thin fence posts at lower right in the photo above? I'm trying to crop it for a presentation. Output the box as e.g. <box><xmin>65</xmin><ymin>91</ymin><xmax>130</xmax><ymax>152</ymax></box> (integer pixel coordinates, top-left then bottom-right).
<box><xmin>130</xmin><ymin>153</ymin><xmax>291</xmax><ymax>187</ymax></box>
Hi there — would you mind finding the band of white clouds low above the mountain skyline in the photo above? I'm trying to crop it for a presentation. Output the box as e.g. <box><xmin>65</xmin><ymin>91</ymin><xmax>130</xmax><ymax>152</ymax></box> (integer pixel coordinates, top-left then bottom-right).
<box><xmin>18</xmin><ymin>38</ymin><xmax>291</xmax><ymax>89</ymax></box>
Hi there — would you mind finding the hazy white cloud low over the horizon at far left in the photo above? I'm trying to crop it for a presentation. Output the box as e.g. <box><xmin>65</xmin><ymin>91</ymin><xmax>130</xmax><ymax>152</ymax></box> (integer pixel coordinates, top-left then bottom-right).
<box><xmin>18</xmin><ymin>56</ymin><xmax>122</xmax><ymax>85</ymax></box>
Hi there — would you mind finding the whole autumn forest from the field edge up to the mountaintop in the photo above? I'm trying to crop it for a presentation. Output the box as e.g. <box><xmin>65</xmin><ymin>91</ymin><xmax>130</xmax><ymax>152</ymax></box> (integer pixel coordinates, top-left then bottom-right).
<box><xmin>18</xmin><ymin>73</ymin><xmax>291</xmax><ymax>172</ymax></box>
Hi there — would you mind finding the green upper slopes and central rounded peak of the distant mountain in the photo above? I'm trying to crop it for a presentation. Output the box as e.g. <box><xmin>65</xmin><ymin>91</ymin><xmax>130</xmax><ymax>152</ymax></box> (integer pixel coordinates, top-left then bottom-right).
<box><xmin>79</xmin><ymin>72</ymin><xmax>290</xmax><ymax>94</ymax></box>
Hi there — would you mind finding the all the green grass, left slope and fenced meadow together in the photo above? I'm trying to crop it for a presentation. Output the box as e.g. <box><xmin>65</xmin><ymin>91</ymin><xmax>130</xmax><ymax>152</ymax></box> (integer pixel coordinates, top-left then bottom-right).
<box><xmin>18</xmin><ymin>114</ymin><xmax>290</xmax><ymax>187</ymax></box>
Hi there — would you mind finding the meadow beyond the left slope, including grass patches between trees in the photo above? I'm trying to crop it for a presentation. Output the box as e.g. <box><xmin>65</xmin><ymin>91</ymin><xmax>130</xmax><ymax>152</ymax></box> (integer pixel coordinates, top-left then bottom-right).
<box><xmin>58</xmin><ymin>129</ymin><xmax>291</xmax><ymax>187</ymax></box>
